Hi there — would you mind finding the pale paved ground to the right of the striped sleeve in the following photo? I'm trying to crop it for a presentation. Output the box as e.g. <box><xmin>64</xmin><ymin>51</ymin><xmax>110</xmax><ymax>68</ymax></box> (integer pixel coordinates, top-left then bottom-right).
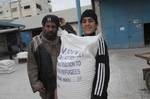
<box><xmin>109</xmin><ymin>48</ymin><xmax>150</xmax><ymax>99</ymax></box>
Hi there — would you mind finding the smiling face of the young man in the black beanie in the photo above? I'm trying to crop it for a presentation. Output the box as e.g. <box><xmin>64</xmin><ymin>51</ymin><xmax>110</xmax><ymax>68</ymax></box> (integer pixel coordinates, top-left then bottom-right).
<box><xmin>81</xmin><ymin>17</ymin><xmax>97</xmax><ymax>36</ymax></box>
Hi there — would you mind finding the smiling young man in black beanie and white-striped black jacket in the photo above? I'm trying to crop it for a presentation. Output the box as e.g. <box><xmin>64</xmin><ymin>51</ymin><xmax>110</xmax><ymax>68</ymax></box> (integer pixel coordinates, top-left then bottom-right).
<box><xmin>80</xmin><ymin>9</ymin><xmax>110</xmax><ymax>99</ymax></box>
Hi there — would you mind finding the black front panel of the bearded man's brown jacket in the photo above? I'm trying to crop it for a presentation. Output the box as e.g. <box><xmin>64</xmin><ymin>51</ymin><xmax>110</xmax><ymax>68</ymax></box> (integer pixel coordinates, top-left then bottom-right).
<box><xmin>34</xmin><ymin>45</ymin><xmax>56</xmax><ymax>90</ymax></box>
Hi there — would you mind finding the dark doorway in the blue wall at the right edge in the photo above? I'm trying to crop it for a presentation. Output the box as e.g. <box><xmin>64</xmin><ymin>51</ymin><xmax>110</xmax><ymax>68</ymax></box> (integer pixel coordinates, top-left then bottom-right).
<box><xmin>144</xmin><ymin>23</ymin><xmax>150</xmax><ymax>45</ymax></box>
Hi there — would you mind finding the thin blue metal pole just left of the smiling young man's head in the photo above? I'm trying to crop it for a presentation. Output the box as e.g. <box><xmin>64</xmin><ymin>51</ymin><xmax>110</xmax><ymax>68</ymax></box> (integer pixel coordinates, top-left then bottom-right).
<box><xmin>76</xmin><ymin>0</ymin><xmax>82</xmax><ymax>36</ymax></box>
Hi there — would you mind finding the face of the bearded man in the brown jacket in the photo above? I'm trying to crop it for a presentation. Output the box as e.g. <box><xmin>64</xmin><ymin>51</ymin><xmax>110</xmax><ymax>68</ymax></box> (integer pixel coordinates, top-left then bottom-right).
<box><xmin>43</xmin><ymin>22</ymin><xmax>57</xmax><ymax>37</ymax></box>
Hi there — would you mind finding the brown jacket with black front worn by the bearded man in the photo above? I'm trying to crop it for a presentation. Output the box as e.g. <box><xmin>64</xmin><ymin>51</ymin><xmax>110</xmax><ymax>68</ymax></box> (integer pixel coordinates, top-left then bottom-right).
<box><xmin>27</xmin><ymin>35</ymin><xmax>61</xmax><ymax>95</ymax></box>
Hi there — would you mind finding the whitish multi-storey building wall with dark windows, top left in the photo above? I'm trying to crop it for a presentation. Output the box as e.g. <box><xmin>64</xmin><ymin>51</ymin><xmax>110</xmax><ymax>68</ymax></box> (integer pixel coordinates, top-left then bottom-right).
<box><xmin>0</xmin><ymin>0</ymin><xmax>52</xmax><ymax>19</ymax></box>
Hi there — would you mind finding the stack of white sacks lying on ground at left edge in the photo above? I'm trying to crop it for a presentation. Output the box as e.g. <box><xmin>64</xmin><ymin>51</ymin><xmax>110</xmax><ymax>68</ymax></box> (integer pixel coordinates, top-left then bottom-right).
<box><xmin>0</xmin><ymin>60</ymin><xmax>16</xmax><ymax>73</ymax></box>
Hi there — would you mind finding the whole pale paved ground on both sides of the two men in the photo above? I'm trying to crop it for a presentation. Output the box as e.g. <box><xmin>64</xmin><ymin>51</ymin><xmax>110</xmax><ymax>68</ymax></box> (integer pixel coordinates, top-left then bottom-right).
<box><xmin>0</xmin><ymin>48</ymin><xmax>150</xmax><ymax>99</ymax></box>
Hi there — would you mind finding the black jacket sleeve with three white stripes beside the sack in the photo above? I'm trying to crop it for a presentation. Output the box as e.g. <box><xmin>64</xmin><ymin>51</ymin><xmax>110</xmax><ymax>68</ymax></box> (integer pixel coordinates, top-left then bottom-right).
<box><xmin>91</xmin><ymin>37</ymin><xmax>110</xmax><ymax>99</ymax></box>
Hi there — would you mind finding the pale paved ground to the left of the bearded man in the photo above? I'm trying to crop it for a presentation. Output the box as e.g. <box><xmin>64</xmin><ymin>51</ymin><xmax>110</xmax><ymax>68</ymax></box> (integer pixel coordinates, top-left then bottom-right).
<box><xmin>0</xmin><ymin>64</ymin><xmax>40</xmax><ymax>99</ymax></box>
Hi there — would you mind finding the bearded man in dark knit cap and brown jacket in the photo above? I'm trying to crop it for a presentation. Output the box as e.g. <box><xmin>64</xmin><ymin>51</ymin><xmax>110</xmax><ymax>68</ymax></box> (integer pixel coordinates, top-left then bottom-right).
<box><xmin>27</xmin><ymin>15</ymin><xmax>60</xmax><ymax>99</ymax></box>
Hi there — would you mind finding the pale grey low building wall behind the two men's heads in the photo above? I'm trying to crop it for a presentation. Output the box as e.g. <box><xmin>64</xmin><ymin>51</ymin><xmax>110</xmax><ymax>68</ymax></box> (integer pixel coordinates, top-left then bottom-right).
<box><xmin>14</xmin><ymin>6</ymin><xmax>91</xmax><ymax>34</ymax></box>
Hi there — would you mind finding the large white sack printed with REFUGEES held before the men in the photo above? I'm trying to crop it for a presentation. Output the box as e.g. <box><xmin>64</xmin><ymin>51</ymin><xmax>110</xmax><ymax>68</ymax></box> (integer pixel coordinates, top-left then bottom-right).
<box><xmin>57</xmin><ymin>34</ymin><xmax>100</xmax><ymax>99</ymax></box>
